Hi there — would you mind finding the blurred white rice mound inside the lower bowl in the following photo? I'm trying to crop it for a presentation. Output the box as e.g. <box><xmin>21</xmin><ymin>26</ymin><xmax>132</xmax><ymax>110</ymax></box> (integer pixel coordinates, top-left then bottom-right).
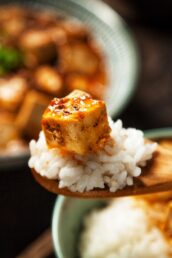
<box><xmin>79</xmin><ymin>198</ymin><xmax>171</xmax><ymax>258</ymax></box>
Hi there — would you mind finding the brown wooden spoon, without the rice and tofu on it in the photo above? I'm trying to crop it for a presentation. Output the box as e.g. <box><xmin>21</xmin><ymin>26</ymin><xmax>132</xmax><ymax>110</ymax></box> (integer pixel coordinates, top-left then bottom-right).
<box><xmin>32</xmin><ymin>139</ymin><xmax>172</xmax><ymax>198</ymax></box>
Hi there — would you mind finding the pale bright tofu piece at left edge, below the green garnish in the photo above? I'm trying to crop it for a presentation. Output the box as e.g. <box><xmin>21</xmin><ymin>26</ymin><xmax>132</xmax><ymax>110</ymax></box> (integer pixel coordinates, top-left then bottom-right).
<box><xmin>0</xmin><ymin>76</ymin><xmax>28</xmax><ymax>111</ymax></box>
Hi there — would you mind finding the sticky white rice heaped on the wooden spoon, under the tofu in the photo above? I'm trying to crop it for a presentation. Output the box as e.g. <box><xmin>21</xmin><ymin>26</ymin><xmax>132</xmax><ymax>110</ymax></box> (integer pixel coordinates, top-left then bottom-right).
<box><xmin>29</xmin><ymin>119</ymin><xmax>157</xmax><ymax>192</ymax></box>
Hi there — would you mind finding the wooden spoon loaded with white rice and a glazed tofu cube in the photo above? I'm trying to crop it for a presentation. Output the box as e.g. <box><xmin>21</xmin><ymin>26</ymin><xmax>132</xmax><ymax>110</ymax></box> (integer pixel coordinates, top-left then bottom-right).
<box><xmin>29</xmin><ymin>90</ymin><xmax>172</xmax><ymax>198</ymax></box>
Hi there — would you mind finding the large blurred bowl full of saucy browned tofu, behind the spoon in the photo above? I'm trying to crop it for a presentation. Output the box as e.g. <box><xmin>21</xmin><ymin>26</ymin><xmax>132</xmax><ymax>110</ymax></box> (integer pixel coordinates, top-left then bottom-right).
<box><xmin>0</xmin><ymin>0</ymin><xmax>137</xmax><ymax>167</ymax></box>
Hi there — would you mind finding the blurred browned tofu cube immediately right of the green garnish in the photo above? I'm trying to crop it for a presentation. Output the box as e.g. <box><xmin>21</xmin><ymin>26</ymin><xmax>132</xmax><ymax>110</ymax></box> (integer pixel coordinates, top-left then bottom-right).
<box><xmin>19</xmin><ymin>30</ymin><xmax>56</xmax><ymax>67</ymax></box>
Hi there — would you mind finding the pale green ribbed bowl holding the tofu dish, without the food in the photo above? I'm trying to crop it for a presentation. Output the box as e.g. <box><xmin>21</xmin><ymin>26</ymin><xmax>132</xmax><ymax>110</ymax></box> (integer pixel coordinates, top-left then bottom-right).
<box><xmin>0</xmin><ymin>0</ymin><xmax>139</xmax><ymax>169</ymax></box>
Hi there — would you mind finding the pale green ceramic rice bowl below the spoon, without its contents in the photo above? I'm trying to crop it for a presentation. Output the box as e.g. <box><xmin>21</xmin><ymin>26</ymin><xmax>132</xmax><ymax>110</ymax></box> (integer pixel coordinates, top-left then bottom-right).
<box><xmin>52</xmin><ymin>128</ymin><xmax>172</xmax><ymax>258</ymax></box>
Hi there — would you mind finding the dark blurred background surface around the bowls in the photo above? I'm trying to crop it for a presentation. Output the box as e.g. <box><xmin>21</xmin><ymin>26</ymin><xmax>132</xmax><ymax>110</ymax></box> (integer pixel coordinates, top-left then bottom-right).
<box><xmin>0</xmin><ymin>0</ymin><xmax>172</xmax><ymax>258</ymax></box>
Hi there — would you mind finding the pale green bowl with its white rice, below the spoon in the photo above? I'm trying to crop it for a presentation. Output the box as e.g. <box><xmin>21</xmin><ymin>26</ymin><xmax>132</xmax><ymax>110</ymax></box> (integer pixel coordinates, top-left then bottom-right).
<box><xmin>52</xmin><ymin>128</ymin><xmax>172</xmax><ymax>258</ymax></box>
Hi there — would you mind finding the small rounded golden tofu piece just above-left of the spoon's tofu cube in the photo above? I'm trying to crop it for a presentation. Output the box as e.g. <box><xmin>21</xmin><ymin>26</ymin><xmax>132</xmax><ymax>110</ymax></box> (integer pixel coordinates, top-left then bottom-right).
<box><xmin>34</xmin><ymin>66</ymin><xmax>63</xmax><ymax>97</ymax></box>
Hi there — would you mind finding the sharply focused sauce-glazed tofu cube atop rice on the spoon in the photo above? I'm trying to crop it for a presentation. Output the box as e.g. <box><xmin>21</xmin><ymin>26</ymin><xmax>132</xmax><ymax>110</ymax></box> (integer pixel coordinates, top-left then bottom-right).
<box><xmin>42</xmin><ymin>90</ymin><xmax>110</xmax><ymax>155</ymax></box>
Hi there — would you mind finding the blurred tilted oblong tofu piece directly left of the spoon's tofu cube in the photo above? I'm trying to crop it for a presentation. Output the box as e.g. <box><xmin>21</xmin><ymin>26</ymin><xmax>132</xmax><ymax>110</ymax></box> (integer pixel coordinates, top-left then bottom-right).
<box><xmin>15</xmin><ymin>91</ymin><xmax>49</xmax><ymax>138</ymax></box>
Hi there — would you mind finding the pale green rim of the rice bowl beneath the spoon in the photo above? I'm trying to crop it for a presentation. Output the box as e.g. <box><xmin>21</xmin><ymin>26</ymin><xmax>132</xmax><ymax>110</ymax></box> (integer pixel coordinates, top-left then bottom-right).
<box><xmin>51</xmin><ymin>127</ymin><xmax>172</xmax><ymax>258</ymax></box>
